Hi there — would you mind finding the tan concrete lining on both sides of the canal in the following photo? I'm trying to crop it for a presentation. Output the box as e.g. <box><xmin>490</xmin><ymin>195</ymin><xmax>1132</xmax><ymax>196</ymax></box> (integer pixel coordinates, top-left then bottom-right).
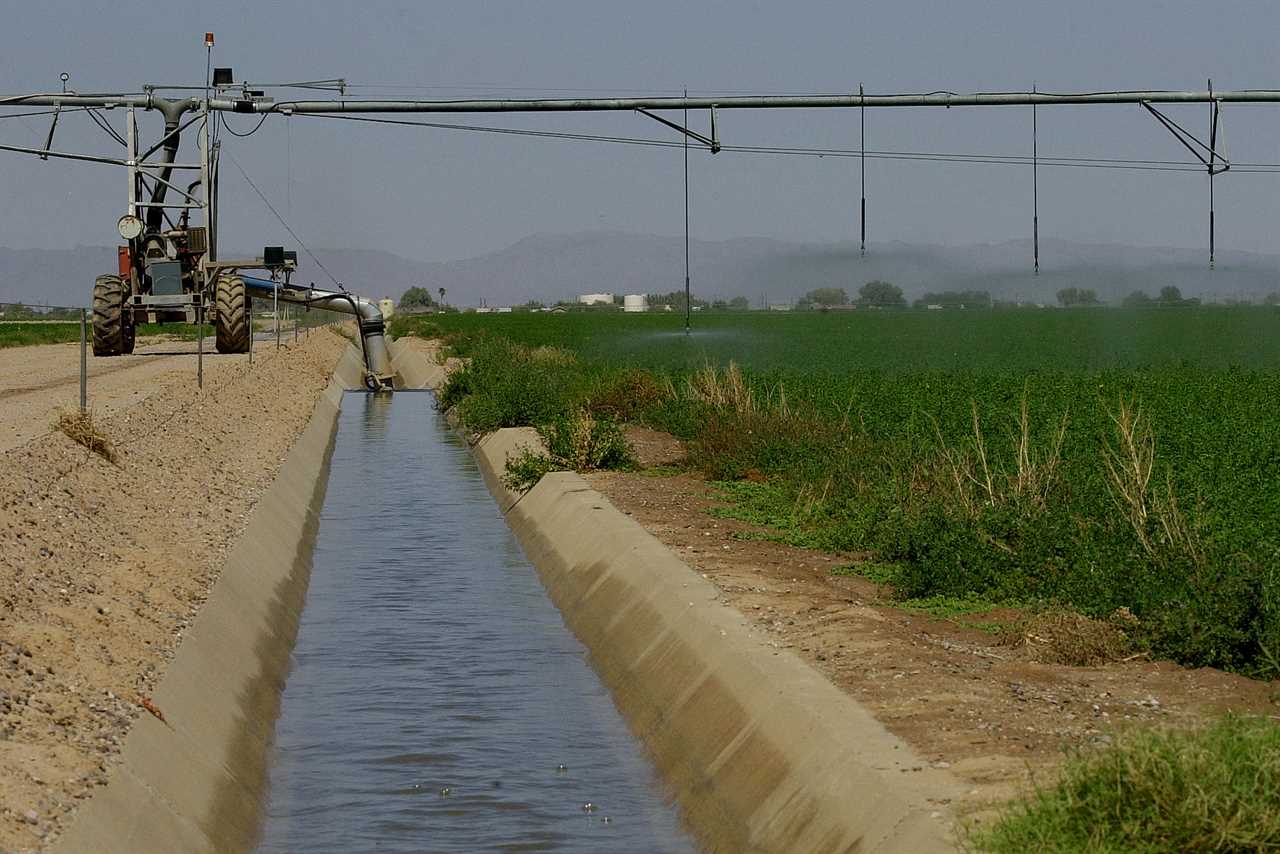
<box><xmin>58</xmin><ymin>338</ymin><xmax>957</xmax><ymax>851</ymax></box>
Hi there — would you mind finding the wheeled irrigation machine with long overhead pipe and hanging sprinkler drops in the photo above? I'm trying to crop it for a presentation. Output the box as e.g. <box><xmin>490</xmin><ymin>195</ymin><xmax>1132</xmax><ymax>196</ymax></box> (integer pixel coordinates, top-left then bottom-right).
<box><xmin>0</xmin><ymin>33</ymin><xmax>1280</xmax><ymax>363</ymax></box>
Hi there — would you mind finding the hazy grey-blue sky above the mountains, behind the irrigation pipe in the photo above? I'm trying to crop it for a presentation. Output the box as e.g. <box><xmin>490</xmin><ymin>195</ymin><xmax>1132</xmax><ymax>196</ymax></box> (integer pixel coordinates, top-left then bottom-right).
<box><xmin>0</xmin><ymin>0</ymin><xmax>1280</xmax><ymax>264</ymax></box>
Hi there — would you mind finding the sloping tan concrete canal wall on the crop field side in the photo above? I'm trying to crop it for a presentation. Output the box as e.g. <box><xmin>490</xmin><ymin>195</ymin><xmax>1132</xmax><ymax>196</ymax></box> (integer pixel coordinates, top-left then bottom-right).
<box><xmin>475</xmin><ymin>448</ymin><xmax>963</xmax><ymax>851</ymax></box>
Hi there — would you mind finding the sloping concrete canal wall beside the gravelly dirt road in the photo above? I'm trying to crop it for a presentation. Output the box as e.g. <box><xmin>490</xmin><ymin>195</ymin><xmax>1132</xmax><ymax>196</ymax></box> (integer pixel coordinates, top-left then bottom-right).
<box><xmin>51</xmin><ymin>347</ymin><xmax>389</xmax><ymax>854</ymax></box>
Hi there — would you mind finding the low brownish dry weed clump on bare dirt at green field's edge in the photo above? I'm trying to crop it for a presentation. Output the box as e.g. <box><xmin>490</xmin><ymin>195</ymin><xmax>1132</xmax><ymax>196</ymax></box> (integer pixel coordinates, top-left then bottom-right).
<box><xmin>1001</xmin><ymin>608</ymin><xmax>1134</xmax><ymax>667</ymax></box>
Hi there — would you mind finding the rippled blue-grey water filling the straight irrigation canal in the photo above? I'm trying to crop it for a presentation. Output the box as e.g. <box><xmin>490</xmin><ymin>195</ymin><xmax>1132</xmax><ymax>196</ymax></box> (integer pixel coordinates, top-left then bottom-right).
<box><xmin>260</xmin><ymin>393</ymin><xmax>692</xmax><ymax>851</ymax></box>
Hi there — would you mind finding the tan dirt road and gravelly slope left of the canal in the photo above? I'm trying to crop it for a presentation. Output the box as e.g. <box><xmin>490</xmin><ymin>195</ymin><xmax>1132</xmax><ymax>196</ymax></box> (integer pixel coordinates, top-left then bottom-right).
<box><xmin>0</xmin><ymin>329</ymin><xmax>349</xmax><ymax>851</ymax></box>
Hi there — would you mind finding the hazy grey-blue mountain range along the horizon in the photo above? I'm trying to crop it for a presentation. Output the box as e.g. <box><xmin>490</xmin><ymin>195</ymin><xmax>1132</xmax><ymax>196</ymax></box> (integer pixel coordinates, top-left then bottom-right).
<box><xmin>0</xmin><ymin>232</ymin><xmax>1280</xmax><ymax>306</ymax></box>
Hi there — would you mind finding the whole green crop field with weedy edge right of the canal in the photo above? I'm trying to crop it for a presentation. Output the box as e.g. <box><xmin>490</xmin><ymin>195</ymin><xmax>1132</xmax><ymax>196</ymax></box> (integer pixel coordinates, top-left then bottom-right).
<box><xmin>394</xmin><ymin>307</ymin><xmax>1280</xmax><ymax>676</ymax></box>
